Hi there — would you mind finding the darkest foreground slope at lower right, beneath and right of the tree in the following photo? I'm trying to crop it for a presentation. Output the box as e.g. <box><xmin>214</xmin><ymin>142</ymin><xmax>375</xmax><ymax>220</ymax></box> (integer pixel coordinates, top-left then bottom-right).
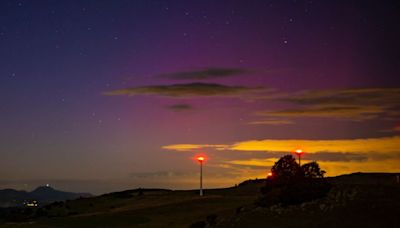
<box><xmin>219</xmin><ymin>173</ymin><xmax>400</xmax><ymax>228</ymax></box>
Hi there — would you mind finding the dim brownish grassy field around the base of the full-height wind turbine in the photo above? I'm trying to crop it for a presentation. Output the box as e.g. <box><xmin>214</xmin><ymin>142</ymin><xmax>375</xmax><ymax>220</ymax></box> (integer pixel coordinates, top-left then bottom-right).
<box><xmin>1</xmin><ymin>184</ymin><xmax>261</xmax><ymax>227</ymax></box>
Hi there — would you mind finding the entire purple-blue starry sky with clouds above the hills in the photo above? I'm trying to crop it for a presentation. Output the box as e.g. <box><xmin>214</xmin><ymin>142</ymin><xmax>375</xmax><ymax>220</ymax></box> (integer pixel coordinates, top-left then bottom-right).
<box><xmin>0</xmin><ymin>0</ymin><xmax>400</xmax><ymax>194</ymax></box>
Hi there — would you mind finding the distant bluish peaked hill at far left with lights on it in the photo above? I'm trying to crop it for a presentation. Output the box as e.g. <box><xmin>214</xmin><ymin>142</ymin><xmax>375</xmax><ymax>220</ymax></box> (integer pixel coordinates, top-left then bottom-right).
<box><xmin>0</xmin><ymin>186</ymin><xmax>92</xmax><ymax>207</ymax></box>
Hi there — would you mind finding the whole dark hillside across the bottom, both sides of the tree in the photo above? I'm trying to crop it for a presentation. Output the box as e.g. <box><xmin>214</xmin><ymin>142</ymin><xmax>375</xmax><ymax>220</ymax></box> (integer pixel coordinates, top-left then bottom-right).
<box><xmin>0</xmin><ymin>174</ymin><xmax>400</xmax><ymax>227</ymax></box>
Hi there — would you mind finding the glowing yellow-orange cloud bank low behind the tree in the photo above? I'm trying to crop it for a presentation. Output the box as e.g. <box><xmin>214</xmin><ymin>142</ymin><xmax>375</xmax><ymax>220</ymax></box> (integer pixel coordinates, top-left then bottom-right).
<box><xmin>163</xmin><ymin>136</ymin><xmax>400</xmax><ymax>178</ymax></box>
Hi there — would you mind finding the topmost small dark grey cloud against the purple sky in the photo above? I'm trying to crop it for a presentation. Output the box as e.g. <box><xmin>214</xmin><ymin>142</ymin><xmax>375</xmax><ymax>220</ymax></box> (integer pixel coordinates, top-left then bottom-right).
<box><xmin>158</xmin><ymin>68</ymin><xmax>249</xmax><ymax>80</ymax></box>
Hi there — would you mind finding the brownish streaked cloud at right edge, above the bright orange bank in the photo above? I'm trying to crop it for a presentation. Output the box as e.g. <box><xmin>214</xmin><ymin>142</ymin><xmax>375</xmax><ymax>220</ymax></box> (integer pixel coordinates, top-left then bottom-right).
<box><xmin>256</xmin><ymin>88</ymin><xmax>400</xmax><ymax>121</ymax></box>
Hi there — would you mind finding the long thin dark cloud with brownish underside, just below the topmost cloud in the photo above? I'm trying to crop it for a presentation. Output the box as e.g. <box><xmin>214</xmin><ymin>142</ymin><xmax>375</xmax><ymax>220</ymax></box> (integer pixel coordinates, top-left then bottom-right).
<box><xmin>104</xmin><ymin>82</ymin><xmax>261</xmax><ymax>97</ymax></box>
